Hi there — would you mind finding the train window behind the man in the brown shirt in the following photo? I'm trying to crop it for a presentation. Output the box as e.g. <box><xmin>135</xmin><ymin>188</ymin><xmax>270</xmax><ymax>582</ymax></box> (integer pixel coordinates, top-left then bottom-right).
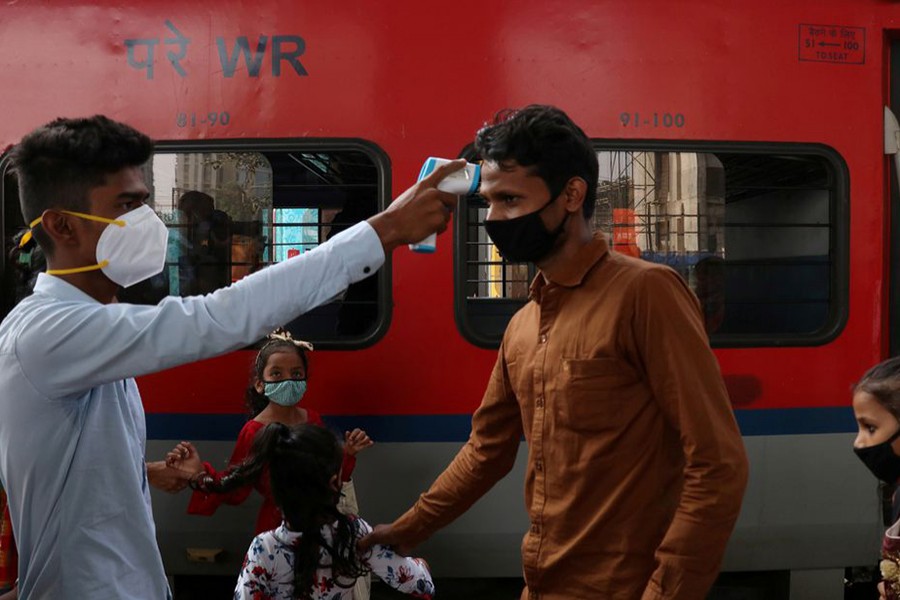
<box><xmin>455</xmin><ymin>142</ymin><xmax>848</xmax><ymax>347</ymax></box>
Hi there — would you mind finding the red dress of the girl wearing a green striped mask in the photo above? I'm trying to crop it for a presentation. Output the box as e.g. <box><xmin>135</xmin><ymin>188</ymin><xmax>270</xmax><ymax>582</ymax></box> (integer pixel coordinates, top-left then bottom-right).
<box><xmin>188</xmin><ymin>408</ymin><xmax>356</xmax><ymax>534</ymax></box>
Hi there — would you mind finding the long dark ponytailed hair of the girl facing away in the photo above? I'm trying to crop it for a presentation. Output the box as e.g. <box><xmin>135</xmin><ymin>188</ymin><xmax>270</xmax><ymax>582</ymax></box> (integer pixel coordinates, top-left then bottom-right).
<box><xmin>207</xmin><ymin>423</ymin><xmax>369</xmax><ymax>600</ymax></box>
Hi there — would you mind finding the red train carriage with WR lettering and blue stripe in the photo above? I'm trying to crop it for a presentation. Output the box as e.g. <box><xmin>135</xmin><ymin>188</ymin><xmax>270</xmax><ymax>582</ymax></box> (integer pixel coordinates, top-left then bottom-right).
<box><xmin>0</xmin><ymin>0</ymin><xmax>900</xmax><ymax>598</ymax></box>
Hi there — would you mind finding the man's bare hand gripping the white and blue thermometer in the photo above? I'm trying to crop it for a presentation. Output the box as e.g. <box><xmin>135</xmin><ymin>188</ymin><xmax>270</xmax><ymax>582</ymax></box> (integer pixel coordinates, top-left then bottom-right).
<box><xmin>369</xmin><ymin>159</ymin><xmax>466</xmax><ymax>254</ymax></box>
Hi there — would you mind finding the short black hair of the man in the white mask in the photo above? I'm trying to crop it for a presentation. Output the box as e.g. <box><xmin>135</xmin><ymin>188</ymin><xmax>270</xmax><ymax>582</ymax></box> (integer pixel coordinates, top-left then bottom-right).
<box><xmin>10</xmin><ymin>115</ymin><xmax>153</xmax><ymax>254</ymax></box>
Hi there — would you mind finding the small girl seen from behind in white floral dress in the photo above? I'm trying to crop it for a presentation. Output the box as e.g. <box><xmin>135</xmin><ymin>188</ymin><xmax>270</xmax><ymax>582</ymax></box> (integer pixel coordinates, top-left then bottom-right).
<box><xmin>216</xmin><ymin>423</ymin><xmax>434</xmax><ymax>600</ymax></box>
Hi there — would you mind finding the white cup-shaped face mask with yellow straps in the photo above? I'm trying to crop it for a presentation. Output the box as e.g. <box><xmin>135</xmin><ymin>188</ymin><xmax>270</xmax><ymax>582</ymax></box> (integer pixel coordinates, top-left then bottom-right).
<box><xmin>30</xmin><ymin>204</ymin><xmax>169</xmax><ymax>287</ymax></box>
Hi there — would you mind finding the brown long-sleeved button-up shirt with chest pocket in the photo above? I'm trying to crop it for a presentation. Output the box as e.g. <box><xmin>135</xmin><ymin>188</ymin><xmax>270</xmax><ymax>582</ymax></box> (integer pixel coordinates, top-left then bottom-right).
<box><xmin>393</xmin><ymin>235</ymin><xmax>747</xmax><ymax>600</ymax></box>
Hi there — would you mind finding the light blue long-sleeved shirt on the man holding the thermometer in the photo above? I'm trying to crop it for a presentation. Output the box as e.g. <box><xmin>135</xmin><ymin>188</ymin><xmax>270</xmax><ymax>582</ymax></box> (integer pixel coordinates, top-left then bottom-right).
<box><xmin>0</xmin><ymin>223</ymin><xmax>384</xmax><ymax>600</ymax></box>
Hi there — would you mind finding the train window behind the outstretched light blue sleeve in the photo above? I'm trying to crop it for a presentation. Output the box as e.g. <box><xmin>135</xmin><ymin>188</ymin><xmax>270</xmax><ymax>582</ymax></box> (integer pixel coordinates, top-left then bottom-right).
<box><xmin>3</xmin><ymin>141</ymin><xmax>390</xmax><ymax>348</ymax></box>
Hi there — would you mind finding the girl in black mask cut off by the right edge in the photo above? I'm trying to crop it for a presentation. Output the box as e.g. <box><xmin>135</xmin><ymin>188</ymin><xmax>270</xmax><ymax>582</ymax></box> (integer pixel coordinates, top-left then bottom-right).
<box><xmin>853</xmin><ymin>357</ymin><xmax>900</xmax><ymax>600</ymax></box>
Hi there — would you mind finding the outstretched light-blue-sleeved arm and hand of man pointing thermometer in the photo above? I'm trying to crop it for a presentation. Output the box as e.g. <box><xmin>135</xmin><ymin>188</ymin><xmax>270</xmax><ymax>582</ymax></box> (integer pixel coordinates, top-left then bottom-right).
<box><xmin>15</xmin><ymin>161</ymin><xmax>464</xmax><ymax>398</ymax></box>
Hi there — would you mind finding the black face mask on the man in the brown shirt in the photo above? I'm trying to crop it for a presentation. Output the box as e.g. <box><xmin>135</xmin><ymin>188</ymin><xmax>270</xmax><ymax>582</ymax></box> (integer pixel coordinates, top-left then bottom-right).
<box><xmin>484</xmin><ymin>195</ymin><xmax>569</xmax><ymax>262</ymax></box>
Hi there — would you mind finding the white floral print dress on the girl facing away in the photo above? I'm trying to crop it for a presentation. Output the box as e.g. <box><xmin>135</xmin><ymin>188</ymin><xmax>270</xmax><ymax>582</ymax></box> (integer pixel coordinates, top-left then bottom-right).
<box><xmin>234</xmin><ymin>517</ymin><xmax>434</xmax><ymax>600</ymax></box>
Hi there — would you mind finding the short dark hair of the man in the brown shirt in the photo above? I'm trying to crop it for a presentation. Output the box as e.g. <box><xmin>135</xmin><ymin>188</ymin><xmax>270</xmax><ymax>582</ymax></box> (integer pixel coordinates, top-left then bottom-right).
<box><xmin>475</xmin><ymin>104</ymin><xmax>600</xmax><ymax>219</ymax></box>
